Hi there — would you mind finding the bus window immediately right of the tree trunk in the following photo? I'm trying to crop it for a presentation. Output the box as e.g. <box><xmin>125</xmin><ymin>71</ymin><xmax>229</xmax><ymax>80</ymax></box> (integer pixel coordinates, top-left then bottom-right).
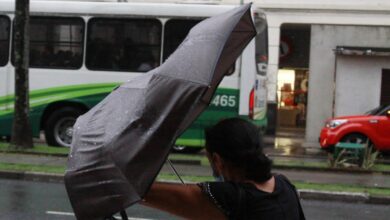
<box><xmin>30</xmin><ymin>17</ymin><xmax>84</xmax><ymax>69</ymax></box>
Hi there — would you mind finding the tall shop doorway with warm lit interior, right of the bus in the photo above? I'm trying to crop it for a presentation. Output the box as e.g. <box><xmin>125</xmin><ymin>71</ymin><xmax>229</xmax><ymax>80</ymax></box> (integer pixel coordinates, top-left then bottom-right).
<box><xmin>276</xmin><ymin>24</ymin><xmax>311</xmax><ymax>139</ymax></box>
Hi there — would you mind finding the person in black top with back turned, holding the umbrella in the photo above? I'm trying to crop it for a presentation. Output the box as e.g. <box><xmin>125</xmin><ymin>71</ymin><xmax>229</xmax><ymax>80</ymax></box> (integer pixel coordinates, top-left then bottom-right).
<box><xmin>142</xmin><ymin>118</ymin><xmax>305</xmax><ymax>220</ymax></box>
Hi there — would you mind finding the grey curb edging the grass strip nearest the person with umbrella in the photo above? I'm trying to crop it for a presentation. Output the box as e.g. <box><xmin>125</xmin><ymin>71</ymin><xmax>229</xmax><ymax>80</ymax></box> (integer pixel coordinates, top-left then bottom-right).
<box><xmin>0</xmin><ymin>171</ymin><xmax>390</xmax><ymax>205</ymax></box>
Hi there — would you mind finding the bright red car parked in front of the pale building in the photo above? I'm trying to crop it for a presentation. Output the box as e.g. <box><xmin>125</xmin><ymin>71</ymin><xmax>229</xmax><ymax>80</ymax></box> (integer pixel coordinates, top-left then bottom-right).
<box><xmin>319</xmin><ymin>105</ymin><xmax>390</xmax><ymax>151</ymax></box>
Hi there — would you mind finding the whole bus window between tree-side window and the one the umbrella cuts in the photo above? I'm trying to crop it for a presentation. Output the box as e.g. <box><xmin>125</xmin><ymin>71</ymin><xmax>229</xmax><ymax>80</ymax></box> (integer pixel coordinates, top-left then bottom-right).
<box><xmin>86</xmin><ymin>18</ymin><xmax>162</xmax><ymax>72</ymax></box>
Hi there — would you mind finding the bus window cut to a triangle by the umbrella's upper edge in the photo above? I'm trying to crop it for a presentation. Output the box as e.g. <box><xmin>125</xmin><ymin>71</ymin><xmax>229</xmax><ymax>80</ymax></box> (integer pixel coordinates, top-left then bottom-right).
<box><xmin>163</xmin><ymin>19</ymin><xmax>201</xmax><ymax>60</ymax></box>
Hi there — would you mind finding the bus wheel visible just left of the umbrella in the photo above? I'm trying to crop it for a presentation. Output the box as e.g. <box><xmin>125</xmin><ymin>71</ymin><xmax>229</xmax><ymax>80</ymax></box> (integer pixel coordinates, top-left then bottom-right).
<box><xmin>45</xmin><ymin>107</ymin><xmax>83</xmax><ymax>147</ymax></box>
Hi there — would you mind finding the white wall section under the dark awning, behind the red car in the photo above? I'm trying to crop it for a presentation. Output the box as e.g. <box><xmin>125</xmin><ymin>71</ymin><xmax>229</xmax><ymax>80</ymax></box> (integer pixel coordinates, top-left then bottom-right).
<box><xmin>335</xmin><ymin>55</ymin><xmax>390</xmax><ymax>116</ymax></box>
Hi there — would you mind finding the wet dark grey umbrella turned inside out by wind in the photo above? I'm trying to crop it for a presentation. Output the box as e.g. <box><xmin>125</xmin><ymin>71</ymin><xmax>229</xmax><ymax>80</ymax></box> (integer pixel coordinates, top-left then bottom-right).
<box><xmin>65</xmin><ymin>4</ymin><xmax>256</xmax><ymax>219</ymax></box>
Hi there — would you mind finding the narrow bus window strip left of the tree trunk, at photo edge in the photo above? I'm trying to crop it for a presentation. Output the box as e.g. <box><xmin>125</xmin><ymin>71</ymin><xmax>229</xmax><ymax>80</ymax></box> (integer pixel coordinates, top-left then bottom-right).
<box><xmin>0</xmin><ymin>16</ymin><xmax>10</xmax><ymax>66</ymax></box>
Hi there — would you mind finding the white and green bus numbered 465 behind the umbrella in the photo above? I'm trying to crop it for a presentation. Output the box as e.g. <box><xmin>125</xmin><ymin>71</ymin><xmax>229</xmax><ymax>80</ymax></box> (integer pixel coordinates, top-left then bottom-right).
<box><xmin>0</xmin><ymin>0</ymin><xmax>268</xmax><ymax>149</ymax></box>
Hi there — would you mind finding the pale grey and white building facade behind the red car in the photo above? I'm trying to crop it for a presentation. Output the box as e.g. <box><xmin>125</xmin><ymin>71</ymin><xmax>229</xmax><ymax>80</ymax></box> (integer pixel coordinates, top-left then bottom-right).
<box><xmin>255</xmin><ymin>0</ymin><xmax>390</xmax><ymax>146</ymax></box>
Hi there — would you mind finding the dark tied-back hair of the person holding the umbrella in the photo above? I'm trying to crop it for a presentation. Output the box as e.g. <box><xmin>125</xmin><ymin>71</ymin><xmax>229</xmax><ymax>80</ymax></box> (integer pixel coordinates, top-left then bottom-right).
<box><xmin>205</xmin><ymin>118</ymin><xmax>272</xmax><ymax>182</ymax></box>
